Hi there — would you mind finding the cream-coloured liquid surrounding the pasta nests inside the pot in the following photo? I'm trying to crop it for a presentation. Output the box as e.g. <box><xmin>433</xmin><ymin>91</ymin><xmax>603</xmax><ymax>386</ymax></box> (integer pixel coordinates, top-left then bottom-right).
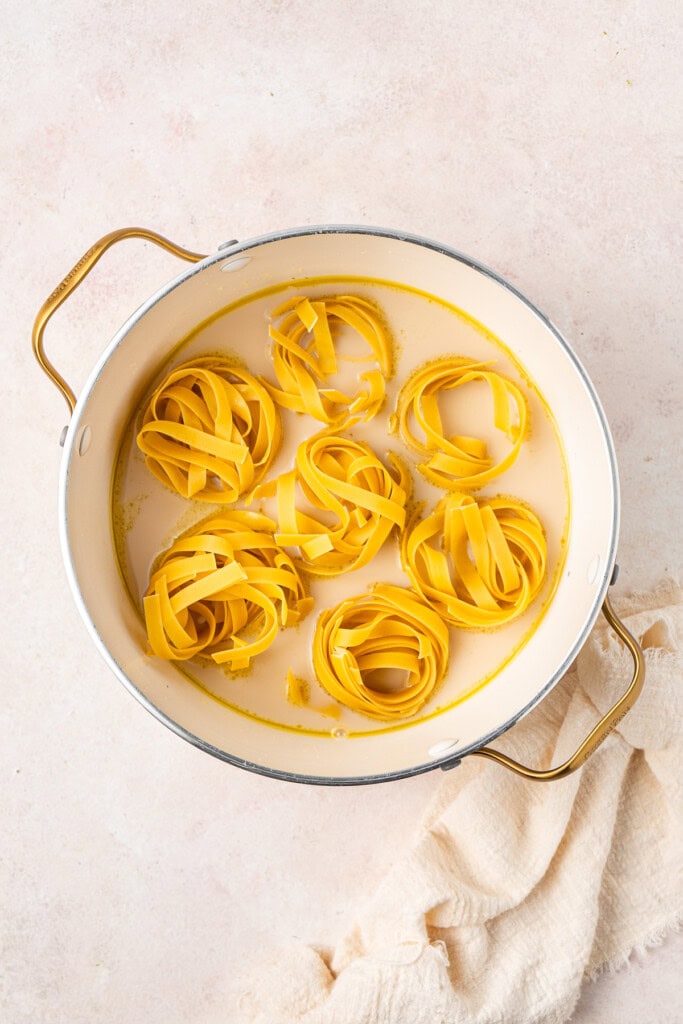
<box><xmin>113</xmin><ymin>279</ymin><xmax>569</xmax><ymax>736</ymax></box>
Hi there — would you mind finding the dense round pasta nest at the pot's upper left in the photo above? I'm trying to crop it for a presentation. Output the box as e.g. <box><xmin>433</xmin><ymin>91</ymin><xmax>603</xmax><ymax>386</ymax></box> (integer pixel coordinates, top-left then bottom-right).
<box><xmin>137</xmin><ymin>356</ymin><xmax>282</xmax><ymax>504</ymax></box>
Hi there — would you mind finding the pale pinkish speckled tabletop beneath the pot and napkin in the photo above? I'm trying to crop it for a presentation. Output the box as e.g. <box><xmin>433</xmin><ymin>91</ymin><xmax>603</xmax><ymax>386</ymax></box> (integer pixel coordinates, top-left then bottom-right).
<box><xmin>0</xmin><ymin>0</ymin><xmax>683</xmax><ymax>1024</ymax></box>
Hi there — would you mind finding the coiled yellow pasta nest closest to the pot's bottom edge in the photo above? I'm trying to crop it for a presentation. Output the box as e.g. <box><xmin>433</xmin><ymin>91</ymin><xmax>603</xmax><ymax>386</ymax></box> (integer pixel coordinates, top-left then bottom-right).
<box><xmin>313</xmin><ymin>584</ymin><xmax>449</xmax><ymax>722</ymax></box>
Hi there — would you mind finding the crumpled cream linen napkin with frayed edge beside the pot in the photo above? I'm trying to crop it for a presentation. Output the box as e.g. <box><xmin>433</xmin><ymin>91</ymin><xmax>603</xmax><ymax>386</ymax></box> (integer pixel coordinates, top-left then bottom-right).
<box><xmin>239</xmin><ymin>583</ymin><xmax>683</xmax><ymax>1024</ymax></box>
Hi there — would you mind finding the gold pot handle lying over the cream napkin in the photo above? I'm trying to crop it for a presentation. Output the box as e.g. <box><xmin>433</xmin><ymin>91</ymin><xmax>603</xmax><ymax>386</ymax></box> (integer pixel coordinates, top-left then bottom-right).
<box><xmin>472</xmin><ymin>598</ymin><xmax>645</xmax><ymax>782</ymax></box>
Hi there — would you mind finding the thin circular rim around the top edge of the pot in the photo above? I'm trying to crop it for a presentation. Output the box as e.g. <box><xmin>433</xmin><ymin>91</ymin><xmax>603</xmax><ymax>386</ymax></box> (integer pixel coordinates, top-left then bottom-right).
<box><xmin>58</xmin><ymin>223</ymin><xmax>620</xmax><ymax>785</ymax></box>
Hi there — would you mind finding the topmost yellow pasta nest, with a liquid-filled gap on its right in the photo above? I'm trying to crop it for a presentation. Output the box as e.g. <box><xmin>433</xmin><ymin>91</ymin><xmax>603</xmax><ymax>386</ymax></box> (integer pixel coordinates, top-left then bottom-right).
<box><xmin>266</xmin><ymin>295</ymin><xmax>393</xmax><ymax>428</ymax></box>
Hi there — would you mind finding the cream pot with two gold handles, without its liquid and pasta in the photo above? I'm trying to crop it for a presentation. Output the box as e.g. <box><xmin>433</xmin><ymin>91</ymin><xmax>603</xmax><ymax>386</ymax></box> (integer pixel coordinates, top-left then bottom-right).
<box><xmin>33</xmin><ymin>225</ymin><xmax>644</xmax><ymax>784</ymax></box>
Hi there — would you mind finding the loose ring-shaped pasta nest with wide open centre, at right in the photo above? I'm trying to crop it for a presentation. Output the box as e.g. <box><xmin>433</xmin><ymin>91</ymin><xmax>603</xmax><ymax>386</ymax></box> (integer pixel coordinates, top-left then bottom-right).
<box><xmin>392</xmin><ymin>357</ymin><xmax>528</xmax><ymax>490</ymax></box>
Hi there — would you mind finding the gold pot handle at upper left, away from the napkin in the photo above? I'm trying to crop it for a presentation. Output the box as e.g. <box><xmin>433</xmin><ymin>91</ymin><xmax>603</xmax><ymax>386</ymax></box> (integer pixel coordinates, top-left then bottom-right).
<box><xmin>33</xmin><ymin>227</ymin><xmax>205</xmax><ymax>413</ymax></box>
